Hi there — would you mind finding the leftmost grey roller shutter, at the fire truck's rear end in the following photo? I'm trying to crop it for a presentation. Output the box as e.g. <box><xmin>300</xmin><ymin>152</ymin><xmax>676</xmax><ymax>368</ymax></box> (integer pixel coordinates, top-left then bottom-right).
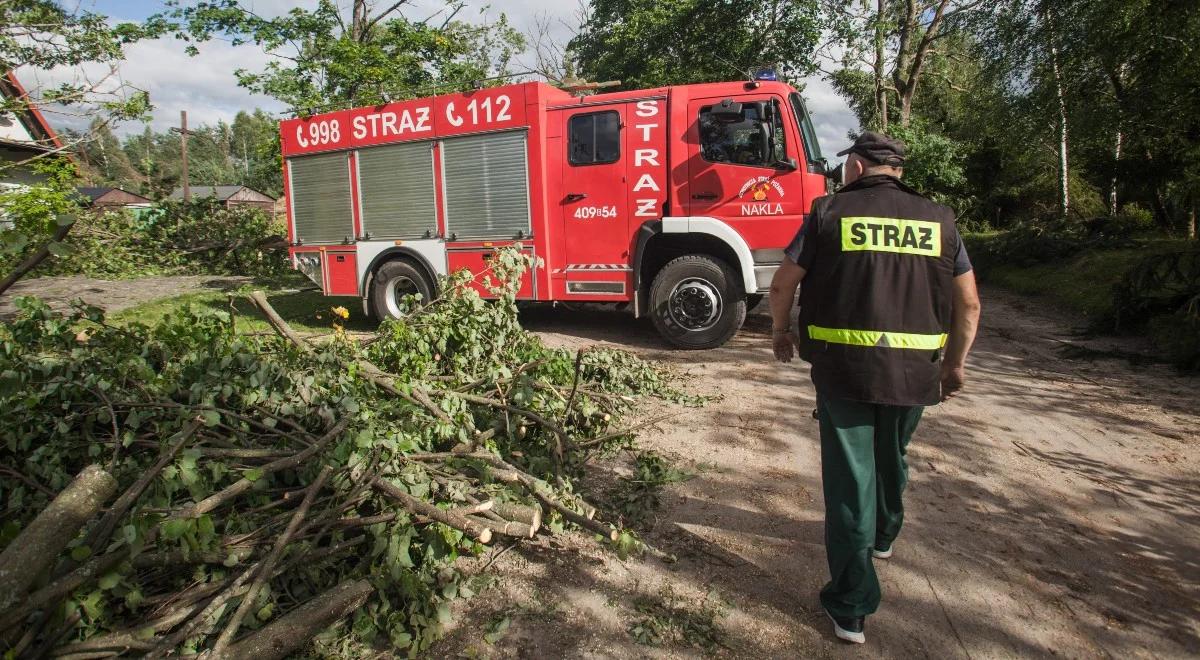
<box><xmin>288</xmin><ymin>151</ymin><xmax>354</xmax><ymax>245</ymax></box>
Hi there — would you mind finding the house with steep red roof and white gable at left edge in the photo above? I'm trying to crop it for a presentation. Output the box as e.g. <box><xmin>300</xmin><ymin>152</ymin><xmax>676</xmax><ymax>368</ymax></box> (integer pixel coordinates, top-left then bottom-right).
<box><xmin>0</xmin><ymin>71</ymin><xmax>62</xmax><ymax>188</ymax></box>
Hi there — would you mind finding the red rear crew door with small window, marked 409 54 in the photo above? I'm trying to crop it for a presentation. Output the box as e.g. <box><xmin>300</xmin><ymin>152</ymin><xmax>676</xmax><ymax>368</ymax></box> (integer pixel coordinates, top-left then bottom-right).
<box><xmin>557</xmin><ymin>106</ymin><xmax>630</xmax><ymax>274</ymax></box>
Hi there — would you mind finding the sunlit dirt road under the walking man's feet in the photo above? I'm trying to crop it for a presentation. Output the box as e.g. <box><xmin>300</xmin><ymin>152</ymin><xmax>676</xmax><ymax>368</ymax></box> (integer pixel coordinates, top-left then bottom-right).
<box><xmin>437</xmin><ymin>290</ymin><xmax>1200</xmax><ymax>659</ymax></box>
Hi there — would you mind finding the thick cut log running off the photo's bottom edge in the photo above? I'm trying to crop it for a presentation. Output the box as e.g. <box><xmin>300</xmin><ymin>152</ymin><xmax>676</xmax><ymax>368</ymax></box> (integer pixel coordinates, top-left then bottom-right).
<box><xmin>223</xmin><ymin>580</ymin><xmax>374</xmax><ymax>660</ymax></box>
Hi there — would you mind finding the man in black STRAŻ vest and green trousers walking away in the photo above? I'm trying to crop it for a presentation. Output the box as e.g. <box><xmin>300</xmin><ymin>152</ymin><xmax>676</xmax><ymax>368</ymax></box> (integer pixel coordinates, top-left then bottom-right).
<box><xmin>770</xmin><ymin>132</ymin><xmax>979</xmax><ymax>643</ymax></box>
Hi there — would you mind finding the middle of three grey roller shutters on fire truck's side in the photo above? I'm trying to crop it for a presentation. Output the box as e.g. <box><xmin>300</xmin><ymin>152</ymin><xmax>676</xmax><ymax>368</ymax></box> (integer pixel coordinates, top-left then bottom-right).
<box><xmin>359</xmin><ymin>142</ymin><xmax>438</xmax><ymax>239</ymax></box>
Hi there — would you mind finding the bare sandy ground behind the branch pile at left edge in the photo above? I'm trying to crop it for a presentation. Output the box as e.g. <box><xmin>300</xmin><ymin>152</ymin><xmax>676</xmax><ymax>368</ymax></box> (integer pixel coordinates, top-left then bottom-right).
<box><xmin>0</xmin><ymin>275</ymin><xmax>251</xmax><ymax>319</ymax></box>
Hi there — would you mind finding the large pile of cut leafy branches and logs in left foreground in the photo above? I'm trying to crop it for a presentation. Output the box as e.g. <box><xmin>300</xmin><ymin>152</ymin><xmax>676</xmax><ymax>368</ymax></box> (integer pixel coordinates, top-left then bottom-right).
<box><xmin>0</xmin><ymin>252</ymin><xmax>684</xmax><ymax>658</ymax></box>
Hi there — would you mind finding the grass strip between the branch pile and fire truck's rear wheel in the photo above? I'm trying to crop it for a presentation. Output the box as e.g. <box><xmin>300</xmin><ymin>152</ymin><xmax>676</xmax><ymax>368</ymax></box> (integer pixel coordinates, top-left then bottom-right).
<box><xmin>109</xmin><ymin>287</ymin><xmax>376</xmax><ymax>332</ymax></box>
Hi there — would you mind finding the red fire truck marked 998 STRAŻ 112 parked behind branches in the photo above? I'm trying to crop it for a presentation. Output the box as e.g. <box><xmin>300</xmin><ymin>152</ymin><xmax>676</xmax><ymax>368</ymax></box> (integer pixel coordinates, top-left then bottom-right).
<box><xmin>280</xmin><ymin>80</ymin><xmax>826</xmax><ymax>348</ymax></box>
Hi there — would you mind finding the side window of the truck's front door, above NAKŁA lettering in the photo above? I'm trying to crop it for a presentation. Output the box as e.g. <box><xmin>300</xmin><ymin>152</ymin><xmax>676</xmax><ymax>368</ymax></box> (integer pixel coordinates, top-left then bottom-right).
<box><xmin>700</xmin><ymin>102</ymin><xmax>787</xmax><ymax>167</ymax></box>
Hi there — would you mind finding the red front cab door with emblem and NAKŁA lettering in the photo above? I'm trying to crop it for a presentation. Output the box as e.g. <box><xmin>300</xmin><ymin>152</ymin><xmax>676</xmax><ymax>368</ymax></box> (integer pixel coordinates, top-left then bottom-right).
<box><xmin>684</xmin><ymin>94</ymin><xmax>808</xmax><ymax>246</ymax></box>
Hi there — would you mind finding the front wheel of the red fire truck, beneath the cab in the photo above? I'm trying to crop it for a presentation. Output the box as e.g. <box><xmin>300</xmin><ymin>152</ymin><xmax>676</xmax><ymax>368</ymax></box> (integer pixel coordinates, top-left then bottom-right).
<box><xmin>650</xmin><ymin>254</ymin><xmax>746</xmax><ymax>350</ymax></box>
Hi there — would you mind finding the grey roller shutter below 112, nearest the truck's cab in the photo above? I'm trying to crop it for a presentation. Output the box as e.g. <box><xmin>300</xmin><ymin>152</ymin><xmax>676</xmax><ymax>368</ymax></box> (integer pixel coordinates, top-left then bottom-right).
<box><xmin>443</xmin><ymin>131</ymin><xmax>529</xmax><ymax>240</ymax></box>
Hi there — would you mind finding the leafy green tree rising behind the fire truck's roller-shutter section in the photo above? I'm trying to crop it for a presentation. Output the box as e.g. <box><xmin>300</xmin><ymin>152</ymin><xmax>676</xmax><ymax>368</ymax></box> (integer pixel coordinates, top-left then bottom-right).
<box><xmin>158</xmin><ymin>0</ymin><xmax>523</xmax><ymax>114</ymax></box>
